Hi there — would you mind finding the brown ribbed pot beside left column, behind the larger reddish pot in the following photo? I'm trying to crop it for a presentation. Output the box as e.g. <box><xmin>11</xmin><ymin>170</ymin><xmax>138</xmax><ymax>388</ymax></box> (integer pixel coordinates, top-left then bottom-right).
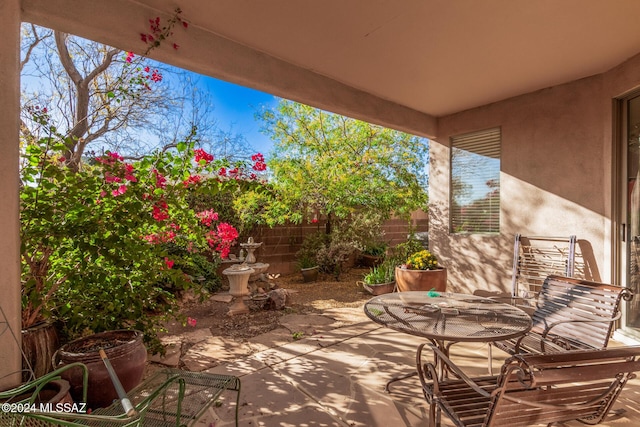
<box><xmin>22</xmin><ymin>322</ymin><xmax>60</xmax><ymax>382</ymax></box>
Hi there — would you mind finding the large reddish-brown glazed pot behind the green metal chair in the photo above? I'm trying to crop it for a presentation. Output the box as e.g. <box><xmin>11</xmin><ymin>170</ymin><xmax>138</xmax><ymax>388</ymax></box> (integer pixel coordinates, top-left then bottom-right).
<box><xmin>54</xmin><ymin>330</ymin><xmax>147</xmax><ymax>409</ymax></box>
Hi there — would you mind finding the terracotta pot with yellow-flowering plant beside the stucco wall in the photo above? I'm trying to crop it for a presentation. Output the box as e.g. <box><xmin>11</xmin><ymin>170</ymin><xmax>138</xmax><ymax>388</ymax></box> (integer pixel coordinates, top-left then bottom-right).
<box><xmin>395</xmin><ymin>249</ymin><xmax>447</xmax><ymax>292</ymax></box>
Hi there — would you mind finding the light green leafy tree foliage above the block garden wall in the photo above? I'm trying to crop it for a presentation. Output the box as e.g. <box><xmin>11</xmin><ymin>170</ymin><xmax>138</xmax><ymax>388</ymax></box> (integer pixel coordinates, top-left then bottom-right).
<box><xmin>236</xmin><ymin>100</ymin><xmax>427</xmax><ymax>232</ymax></box>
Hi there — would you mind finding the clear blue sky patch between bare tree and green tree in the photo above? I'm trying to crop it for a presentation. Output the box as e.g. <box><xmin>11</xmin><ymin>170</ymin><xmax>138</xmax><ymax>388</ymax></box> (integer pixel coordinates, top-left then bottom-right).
<box><xmin>201</xmin><ymin>76</ymin><xmax>278</xmax><ymax>155</ymax></box>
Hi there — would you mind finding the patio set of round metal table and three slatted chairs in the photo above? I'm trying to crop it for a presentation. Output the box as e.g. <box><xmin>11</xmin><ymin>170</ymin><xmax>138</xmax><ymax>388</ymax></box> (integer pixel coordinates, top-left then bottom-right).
<box><xmin>364</xmin><ymin>236</ymin><xmax>640</xmax><ymax>427</ymax></box>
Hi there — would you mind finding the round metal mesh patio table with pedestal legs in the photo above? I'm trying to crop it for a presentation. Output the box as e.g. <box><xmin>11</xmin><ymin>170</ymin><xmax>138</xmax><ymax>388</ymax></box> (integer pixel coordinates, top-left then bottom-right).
<box><xmin>364</xmin><ymin>291</ymin><xmax>532</xmax><ymax>391</ymax></box>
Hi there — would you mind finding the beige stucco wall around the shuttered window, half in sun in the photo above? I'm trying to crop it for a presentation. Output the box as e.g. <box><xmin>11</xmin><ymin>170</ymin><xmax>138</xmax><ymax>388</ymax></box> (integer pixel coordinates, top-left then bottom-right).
<box><xmin>429</xmin><ymin>52</ymin><xmax>640</xmax><ymax>291</ymax></box>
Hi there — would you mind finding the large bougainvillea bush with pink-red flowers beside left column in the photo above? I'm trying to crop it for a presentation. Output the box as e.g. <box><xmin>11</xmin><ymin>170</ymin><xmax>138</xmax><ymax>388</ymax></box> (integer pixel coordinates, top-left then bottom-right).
<box><xmin>20</xmin><ymin>118</ymin><xmax>262</xmax><ymax>350</ymax></box>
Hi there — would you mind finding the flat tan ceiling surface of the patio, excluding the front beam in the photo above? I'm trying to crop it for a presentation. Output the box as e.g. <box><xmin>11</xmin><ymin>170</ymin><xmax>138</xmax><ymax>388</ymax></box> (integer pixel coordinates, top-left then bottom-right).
<box><xmin>136</xmin><ymin>0</ymin><xmax>640</xmax><ymax>117</ymax></box>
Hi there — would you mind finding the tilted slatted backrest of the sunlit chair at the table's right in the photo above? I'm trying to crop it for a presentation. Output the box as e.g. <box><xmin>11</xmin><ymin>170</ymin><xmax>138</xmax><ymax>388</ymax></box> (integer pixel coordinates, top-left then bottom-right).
<box><xmin>531</xmin><ymin>275</ymin><xmax>633</xmax><ymax>348</ymax></box>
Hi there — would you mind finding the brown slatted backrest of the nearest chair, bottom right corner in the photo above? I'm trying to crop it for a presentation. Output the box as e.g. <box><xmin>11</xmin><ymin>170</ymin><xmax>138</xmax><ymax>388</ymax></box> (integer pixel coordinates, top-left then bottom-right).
<box><xmin>483</xmin><ymin>347</ymin><xmax>640</xmax><ymax>427</ymax></box>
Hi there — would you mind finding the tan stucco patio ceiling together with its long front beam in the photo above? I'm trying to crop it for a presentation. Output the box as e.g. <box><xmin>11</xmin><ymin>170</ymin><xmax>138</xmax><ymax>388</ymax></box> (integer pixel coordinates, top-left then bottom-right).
<box><xmin>21</xmin><ymin>0</ymin><xmax>640</xmax><ymax>136</ymax></box>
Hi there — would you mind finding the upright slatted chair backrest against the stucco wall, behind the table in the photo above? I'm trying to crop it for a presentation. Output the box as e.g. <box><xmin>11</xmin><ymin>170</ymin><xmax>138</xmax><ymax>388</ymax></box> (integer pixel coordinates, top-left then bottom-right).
<box><xmin>511</xmin><ymin>234</ymin><xmax>576</xmax><ymax>305</ymax></box>
